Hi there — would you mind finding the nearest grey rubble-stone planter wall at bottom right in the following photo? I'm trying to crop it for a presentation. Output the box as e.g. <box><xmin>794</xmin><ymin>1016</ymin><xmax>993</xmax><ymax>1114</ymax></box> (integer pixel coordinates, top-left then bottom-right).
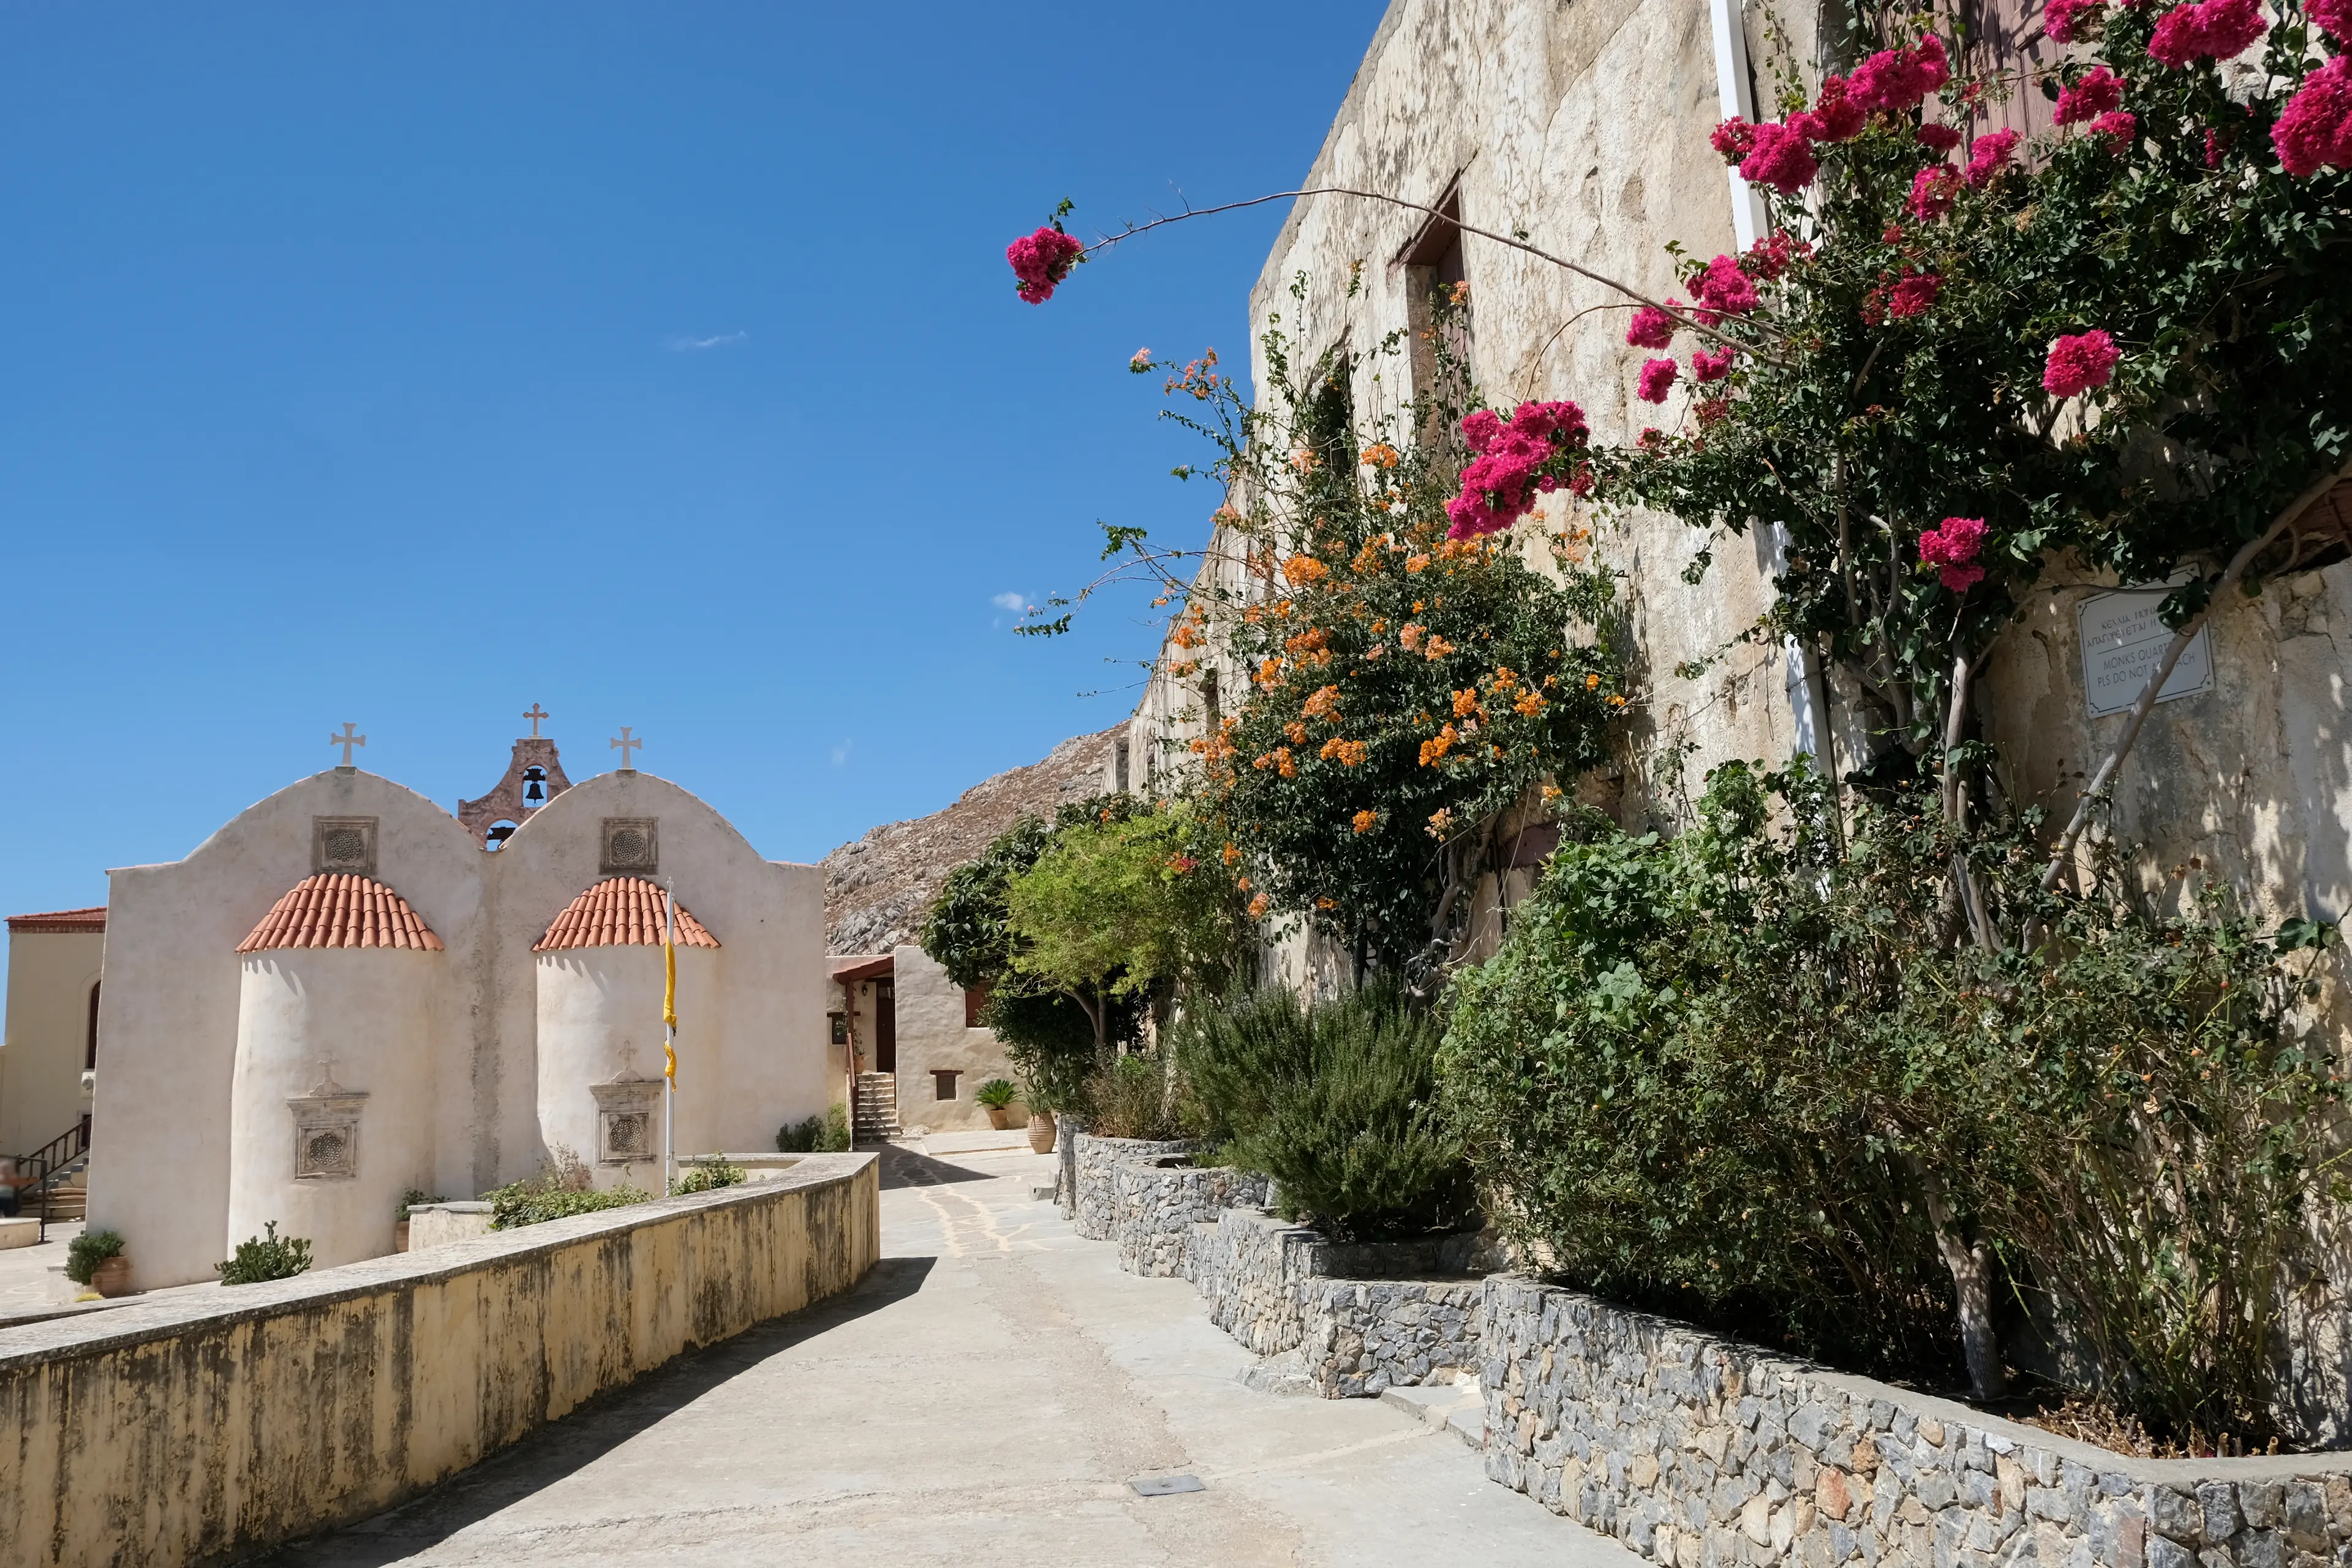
<box><xmin>1475</xmin><ymin>1276</ymin><xmax>2352</xmax><ymax>1568</ymax></box>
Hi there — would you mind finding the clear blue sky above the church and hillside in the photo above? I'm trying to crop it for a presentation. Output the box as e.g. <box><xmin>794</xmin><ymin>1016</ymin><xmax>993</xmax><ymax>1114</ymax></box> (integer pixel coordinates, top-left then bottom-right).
<box><xmin>0</xmin><ymin>0</ymin><xmax>1381</xmax><ymax>930</ymax></box>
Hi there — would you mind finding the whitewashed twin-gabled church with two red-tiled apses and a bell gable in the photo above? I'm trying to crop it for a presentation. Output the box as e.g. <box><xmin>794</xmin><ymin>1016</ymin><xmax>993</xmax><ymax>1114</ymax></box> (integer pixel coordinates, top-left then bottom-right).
<box><xmin>89</xmin><ymin>724</ymin><xmax>840</xmax><ymax>1288</ymax></box>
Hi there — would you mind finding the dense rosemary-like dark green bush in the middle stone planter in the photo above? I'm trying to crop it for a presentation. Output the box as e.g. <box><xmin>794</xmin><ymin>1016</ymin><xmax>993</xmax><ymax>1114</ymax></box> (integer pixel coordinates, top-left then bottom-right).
<box><xmin>1176</xmin><ymin>982</ymin><xmax>1472</xmax><ymax>1239</ymax></box>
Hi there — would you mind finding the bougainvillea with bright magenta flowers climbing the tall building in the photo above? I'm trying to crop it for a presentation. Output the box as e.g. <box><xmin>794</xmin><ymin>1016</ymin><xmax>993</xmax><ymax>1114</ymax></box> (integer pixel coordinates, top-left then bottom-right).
<box><xmin>1453</xmin><ymin>0</ymin><xmax>2352</xmax><ymax>893</ymax></box>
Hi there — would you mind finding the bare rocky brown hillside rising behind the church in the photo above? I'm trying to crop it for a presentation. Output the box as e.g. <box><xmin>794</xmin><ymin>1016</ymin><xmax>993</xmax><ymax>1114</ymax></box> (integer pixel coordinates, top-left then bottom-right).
<box><xmin>818</xmin><ymin>724</ymin><xmax>1126</xmax><ymax>952</ymax></box>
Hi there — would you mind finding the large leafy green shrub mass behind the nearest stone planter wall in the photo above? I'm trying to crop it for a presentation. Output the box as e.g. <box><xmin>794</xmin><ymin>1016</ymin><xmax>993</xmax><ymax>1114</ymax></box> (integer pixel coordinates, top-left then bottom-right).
<box><xmin>1442</xmin><ymin>766</ymin><xmax>2343</xmax><ymax>1446</ymax></box>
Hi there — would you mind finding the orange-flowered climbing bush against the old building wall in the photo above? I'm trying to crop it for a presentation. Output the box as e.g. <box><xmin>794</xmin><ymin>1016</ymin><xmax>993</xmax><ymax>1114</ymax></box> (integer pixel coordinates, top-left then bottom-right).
<box><xmin>1143</xmin><ymin>297</ymin><xmax>1625</xmax><ymax>971</ymax></box>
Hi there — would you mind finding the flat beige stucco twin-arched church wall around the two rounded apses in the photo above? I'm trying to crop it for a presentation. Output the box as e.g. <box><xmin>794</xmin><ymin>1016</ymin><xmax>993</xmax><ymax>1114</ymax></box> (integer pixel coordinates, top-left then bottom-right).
<box><xmin>89</xmin><ymin>769</ymin><xmax>831</xmax><ymax>1286</ymax></box>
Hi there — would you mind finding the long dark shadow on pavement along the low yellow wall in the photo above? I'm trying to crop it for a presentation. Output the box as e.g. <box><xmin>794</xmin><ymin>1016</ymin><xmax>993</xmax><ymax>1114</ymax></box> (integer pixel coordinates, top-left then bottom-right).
<box><xmin>247</xmin><ymin>1257</ymin><xmax>936</xmax><ymax>1568</ymax></box>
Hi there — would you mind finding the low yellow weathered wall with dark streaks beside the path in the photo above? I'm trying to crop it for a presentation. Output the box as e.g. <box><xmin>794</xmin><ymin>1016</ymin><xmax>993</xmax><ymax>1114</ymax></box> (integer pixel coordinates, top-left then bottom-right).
<box><xmin>0</xmin><ymin>1154</ymin><xmax>882</xmax><ymax>1568</ymax></box>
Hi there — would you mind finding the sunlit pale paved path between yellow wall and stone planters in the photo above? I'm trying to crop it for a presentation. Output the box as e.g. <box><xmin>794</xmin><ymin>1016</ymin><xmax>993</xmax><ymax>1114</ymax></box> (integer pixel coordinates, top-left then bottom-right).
<box><xmin>271</xmin><ymin>1150</ymin><xmax>1642</xmax><ymax>1568</ymax></box>
